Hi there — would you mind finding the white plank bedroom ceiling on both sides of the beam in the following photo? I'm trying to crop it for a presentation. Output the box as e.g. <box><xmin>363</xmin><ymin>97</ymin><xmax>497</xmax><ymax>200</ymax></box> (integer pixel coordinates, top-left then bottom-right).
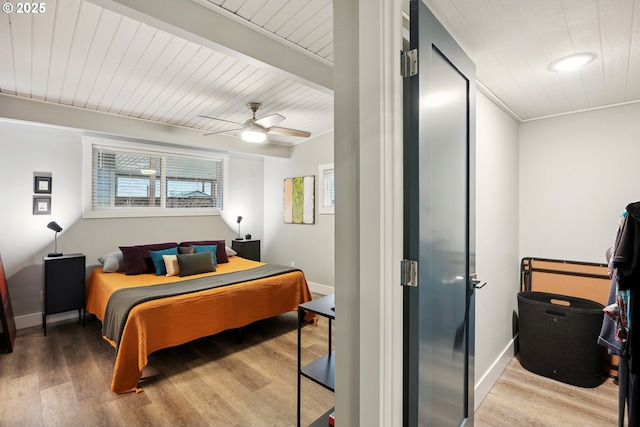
<box><xmin>0</xmin><ymin>0</ymin><xmax>333</xmax><ymax>144</ymax></box>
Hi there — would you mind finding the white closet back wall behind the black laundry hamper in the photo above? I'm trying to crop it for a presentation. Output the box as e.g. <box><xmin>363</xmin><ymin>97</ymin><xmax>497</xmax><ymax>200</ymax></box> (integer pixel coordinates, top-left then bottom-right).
<box><xmin>519</xmin><ymin>103</ymin><xmax>640</xmax><ymax>262</ymax></box>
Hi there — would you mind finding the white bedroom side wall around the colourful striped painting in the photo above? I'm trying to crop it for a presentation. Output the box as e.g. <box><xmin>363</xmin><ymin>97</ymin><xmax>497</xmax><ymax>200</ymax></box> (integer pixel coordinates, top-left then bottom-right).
<box><xmin>263</xmin><ymin>132</ymin><xmax>340</xmax><ymax>293</ymax></box>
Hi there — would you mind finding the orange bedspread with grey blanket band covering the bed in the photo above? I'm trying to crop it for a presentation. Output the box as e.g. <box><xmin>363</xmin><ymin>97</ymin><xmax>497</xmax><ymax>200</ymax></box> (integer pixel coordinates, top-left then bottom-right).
<box><xmin>86</xmin><ymin>242</ymin><xmax>312</xmax><ymax>393</ymax></box>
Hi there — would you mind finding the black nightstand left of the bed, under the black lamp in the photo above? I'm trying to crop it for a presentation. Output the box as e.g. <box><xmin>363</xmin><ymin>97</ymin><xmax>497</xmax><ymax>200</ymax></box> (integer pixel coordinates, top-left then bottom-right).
<box><xmin>42</xmin><ymin>254</ymin><xmax>86</xmax><ymax>335</ymax></box>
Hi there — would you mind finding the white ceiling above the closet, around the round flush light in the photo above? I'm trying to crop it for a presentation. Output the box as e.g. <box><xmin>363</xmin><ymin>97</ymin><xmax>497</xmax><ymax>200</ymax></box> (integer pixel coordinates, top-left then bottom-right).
<box><xmin>426</xmin><ymin>0</ymin><xmax>640</xmax><ymax>120</ymax></box>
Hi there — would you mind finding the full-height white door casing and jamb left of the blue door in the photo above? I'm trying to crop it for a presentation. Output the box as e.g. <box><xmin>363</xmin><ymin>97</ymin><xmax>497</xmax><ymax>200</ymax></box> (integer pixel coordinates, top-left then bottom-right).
<box><xmin>358</xmin><ymin>0</ymin><xmax>403</xmax><ymax>426</ymax></box>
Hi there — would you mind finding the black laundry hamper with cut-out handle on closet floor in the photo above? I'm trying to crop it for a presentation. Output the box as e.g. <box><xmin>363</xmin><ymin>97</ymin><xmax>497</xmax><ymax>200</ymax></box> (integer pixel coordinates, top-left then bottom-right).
<box><xmin>518</xmin><ymin>291</ymin><xmax>604</xmax><ymax>388</ymax></box>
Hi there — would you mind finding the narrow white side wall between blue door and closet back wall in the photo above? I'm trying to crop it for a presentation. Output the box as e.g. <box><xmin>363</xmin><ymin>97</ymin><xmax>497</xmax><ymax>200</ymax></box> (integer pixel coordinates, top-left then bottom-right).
<box><xmin>474</xmin><ymin>92</ymin><xmax>520</xmax><ymax>408</ymax></box>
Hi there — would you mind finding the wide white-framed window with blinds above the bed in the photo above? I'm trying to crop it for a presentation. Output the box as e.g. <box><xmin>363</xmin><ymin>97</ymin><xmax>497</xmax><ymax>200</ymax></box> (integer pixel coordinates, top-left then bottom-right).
<box><xmin>84</xmin><ymin>137</ymin><xmax>226</xmax><ymax>217</ymax></box>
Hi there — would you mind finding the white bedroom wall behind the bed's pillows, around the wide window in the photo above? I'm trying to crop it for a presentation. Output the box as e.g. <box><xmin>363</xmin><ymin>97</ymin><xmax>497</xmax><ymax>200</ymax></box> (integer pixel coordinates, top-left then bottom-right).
<box><xmin>0</xmin><ymin>121</ymin><xmax>264</xmax><ymax>327</ymax></box>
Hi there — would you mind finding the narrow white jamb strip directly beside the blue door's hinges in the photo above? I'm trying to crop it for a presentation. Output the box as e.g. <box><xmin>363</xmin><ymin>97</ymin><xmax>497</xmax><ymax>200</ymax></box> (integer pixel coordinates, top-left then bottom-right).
<box><xmin>380</xmin><ymin>1</ymin><xmax>404</xmax><ymax>425</ymax></box>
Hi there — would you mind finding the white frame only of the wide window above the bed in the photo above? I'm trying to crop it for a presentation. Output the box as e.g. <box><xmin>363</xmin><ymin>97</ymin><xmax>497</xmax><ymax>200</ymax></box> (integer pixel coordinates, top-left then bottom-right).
<box><xmin>82</xmin><ymin>136</ymin><xmax>229</xmax><ymax>218</ymax></box>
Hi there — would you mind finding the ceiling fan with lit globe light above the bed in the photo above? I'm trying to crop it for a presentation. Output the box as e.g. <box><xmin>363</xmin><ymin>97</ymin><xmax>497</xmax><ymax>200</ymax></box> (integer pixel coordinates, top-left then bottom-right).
<box><xmin>198</xmin><ymin>102</ymin><xmax>311</xmax><ymax>143</ymax></box>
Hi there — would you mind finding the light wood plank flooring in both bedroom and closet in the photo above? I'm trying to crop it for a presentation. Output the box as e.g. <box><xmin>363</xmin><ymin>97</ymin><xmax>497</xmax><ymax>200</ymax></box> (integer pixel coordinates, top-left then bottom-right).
<box><xmin>0</xmin><ymin>312</ymin><xmax>617</xmax><ymax>427</ymax></box>
